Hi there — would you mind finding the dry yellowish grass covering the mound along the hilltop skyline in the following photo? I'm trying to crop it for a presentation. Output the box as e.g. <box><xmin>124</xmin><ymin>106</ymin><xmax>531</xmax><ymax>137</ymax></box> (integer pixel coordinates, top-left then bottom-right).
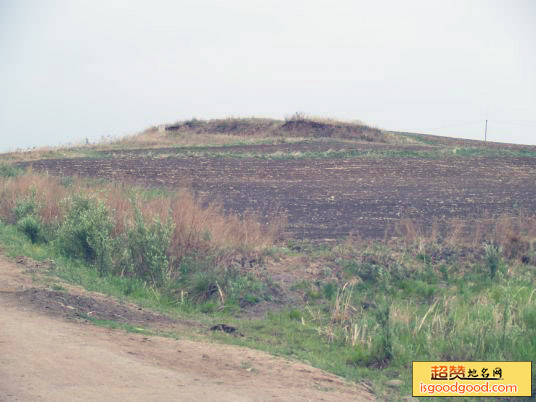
<box><xmin>0</xmin><ymin>113</ymin><xmax>402</xmax><ymax>161</ymax></box>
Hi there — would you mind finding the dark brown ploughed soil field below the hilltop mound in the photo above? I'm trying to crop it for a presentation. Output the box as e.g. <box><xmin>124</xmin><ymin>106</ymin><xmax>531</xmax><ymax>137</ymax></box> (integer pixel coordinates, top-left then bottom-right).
<box><xmin>23</xmin><ymin>149</ymin><xmax>536</xmax><ymax>241</ymax></box>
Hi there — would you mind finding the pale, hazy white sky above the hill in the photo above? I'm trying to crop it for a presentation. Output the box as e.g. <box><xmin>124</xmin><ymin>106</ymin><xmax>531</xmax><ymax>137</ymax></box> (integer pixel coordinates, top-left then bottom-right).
<box><xmin>0</xmin><ymin>0</ymin><xmax>536</xmax><ymax>152</ymax></box>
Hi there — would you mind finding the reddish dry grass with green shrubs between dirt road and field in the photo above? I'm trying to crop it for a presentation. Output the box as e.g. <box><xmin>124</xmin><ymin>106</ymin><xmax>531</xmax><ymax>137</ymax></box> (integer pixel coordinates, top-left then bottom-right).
<box><xmin>0</xmin><ymin>172</ymin><xmax>283</xmax><ymax>292</ymax></box>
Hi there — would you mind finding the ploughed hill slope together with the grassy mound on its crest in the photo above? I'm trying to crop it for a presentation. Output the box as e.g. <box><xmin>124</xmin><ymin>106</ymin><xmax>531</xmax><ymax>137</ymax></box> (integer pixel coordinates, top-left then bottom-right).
<box><xmin>8</xmin><ymin>116</ymin><xmax>536</xmax><ymax>241</ymax></box>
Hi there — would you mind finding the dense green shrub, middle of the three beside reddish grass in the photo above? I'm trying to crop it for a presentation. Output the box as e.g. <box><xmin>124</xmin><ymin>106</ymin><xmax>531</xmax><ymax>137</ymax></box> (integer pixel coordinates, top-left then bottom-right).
<box><xmin>57</xmin><ymin>195</ymin><xmax>113</xmax><ymax>274</ymax></box>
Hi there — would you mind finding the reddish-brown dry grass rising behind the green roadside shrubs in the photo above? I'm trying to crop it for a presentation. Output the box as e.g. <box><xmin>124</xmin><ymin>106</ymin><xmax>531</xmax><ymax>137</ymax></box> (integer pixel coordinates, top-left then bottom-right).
<box><xmin>0</xmin><ymin>172</ymin><xmax>284</xmax><ymax>259</ymax></box>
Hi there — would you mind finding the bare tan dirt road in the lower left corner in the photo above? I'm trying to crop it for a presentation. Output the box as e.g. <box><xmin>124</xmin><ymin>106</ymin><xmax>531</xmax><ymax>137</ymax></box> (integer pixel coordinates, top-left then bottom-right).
<box><xmin>0</xmin><ymin>256</ymin><xmax>374</xmax><ymax>402</ymax></box>
